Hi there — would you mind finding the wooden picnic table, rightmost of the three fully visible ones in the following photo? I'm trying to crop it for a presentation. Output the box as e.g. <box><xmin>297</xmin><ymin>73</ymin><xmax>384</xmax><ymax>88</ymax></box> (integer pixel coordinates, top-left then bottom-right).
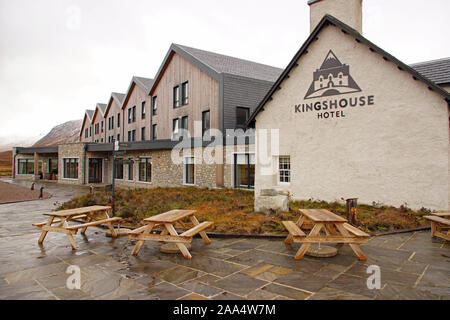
<box><xmin>282</xmin><ymin>209</ymin><xmax>370</xmax><ymax>261</ymax></box>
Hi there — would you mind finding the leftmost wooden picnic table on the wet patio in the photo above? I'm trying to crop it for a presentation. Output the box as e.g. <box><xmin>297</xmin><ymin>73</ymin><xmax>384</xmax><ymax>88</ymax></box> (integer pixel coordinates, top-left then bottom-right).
<box><xmin>33</xmin><ymin>206</ymin><xmax>121</xmax><ymax>250</ymax></box>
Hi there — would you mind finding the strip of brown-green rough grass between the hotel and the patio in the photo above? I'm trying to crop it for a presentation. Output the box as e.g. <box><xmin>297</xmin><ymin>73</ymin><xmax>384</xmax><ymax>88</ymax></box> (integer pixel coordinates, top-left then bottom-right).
<box><xmin>58</xmin><ymin>187</ymin><xmax>429</xmax><ymax>234</ymax></box>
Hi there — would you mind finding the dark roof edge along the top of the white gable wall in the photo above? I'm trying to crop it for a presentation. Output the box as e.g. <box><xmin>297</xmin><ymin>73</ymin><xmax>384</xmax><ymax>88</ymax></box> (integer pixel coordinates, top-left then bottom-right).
<box><xmin>246</xmin><ymin>14</ymin><xmax>450</xmax><ymax>126</ymax></box>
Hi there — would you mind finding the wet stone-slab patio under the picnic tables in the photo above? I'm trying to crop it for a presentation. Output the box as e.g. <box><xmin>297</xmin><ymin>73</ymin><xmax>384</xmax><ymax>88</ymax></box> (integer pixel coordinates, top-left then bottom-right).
<box><xmin>0</xmin><ymin>183</ymin><xmax>450</xmax><ymax>300</ymax></box>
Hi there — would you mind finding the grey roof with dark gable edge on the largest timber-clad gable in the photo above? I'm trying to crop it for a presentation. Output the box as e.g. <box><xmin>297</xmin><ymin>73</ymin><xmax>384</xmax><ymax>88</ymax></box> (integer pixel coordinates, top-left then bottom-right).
<box><xmin>150</xmin><ymin>43</ymin><xmax>283</xmax><ymax>93</ymax></box>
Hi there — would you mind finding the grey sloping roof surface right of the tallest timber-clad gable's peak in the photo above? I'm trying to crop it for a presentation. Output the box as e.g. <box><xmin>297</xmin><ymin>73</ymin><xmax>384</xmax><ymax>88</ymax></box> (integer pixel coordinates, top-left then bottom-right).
<box><xmin>172</xmin><ymin>44</ymin><xmax>283</xmax><ymax>82</ymax></box>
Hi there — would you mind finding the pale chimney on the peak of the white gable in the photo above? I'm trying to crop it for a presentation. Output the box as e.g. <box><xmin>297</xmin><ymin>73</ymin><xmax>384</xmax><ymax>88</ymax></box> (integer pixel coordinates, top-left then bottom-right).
<box><xmin>308</xmin><ymin>0</ymin><xmax>362</xmax><ymax>33</ymax></box>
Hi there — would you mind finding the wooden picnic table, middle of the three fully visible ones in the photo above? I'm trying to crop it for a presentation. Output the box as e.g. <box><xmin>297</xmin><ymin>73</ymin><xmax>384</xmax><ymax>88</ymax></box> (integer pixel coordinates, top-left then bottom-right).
<box><xmin>128</xmin><ymin>210</ymin><xmax>213</xmax><ymax>259</ymax></box>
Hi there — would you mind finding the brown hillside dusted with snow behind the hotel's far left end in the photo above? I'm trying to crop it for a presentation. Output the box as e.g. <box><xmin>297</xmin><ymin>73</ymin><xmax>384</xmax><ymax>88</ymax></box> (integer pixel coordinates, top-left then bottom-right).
<box><xmin>33</xmin><ymin>120</ymin><xmax>82</xmax><ymax>147</ymax></box>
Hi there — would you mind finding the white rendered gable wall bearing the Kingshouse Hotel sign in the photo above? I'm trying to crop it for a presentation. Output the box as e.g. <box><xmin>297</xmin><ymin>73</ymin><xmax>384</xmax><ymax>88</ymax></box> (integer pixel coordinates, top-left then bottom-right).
<box><xmin>255</xmin><ymin>26</ymin><xmax>449</xmax><ymax>209</ymax></box>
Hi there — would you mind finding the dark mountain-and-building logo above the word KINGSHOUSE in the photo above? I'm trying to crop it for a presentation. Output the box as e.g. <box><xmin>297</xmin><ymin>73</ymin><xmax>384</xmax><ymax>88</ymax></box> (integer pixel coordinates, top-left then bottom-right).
<box><xmin>305</xmin><ymin>50</ymin><xmax>361</xmax><ymax>99</ymax></box>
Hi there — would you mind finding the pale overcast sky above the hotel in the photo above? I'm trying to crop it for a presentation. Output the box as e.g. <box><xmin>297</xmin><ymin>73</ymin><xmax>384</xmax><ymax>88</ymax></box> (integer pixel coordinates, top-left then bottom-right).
<box><xmin>0</xmin><ymin>0</ymin><xmax>450</xmax><ymax>143</ymax></box>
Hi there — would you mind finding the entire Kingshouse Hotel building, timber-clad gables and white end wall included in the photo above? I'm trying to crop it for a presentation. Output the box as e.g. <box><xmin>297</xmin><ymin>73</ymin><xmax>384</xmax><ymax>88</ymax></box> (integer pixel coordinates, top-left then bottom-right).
<box><xmin>13</xmin><ymin>0</ymin><xmax>450</xmax><ymax>210</ymax></box>
